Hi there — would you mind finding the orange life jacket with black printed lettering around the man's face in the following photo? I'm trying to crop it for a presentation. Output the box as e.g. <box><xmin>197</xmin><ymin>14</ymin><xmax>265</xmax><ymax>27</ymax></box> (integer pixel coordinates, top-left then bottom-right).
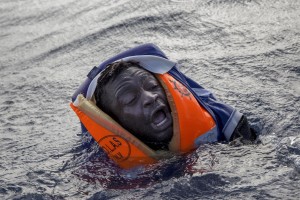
<box><xmin>70</xmin><ymin>73</ymin><xmax>216</xmax><ymax>169</ymax></box>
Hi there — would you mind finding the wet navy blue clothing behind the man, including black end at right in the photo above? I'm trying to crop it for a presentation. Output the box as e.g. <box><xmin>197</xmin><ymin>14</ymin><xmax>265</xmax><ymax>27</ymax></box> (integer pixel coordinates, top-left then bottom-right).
<box><xmin>72</xmin><ymin>44</ymin><xmax>255</xmax><ymax>145</ymax></box>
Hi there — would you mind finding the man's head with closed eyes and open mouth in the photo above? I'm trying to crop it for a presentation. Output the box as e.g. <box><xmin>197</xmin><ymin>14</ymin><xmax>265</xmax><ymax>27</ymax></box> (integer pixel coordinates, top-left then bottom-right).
<box><xmin>95</xmin><ymin>61</ymin><xmax>173</xmax><ymax>149</ymax></box>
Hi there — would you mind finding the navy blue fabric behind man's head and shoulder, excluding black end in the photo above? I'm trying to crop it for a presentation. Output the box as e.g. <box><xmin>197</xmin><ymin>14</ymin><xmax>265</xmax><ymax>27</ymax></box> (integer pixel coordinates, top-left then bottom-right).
<box><xmin>72</xmin><ymin>44</ymin><xmax>242</xmax><ymax>142</ymax></box>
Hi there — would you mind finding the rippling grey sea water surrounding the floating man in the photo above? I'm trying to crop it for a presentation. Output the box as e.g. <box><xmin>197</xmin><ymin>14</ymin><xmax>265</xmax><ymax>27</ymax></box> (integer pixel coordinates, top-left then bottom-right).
<box><xmin>0</xmin><ymin>0</ymin><xmax>300</xmax><ymax>199</ymax></box>
